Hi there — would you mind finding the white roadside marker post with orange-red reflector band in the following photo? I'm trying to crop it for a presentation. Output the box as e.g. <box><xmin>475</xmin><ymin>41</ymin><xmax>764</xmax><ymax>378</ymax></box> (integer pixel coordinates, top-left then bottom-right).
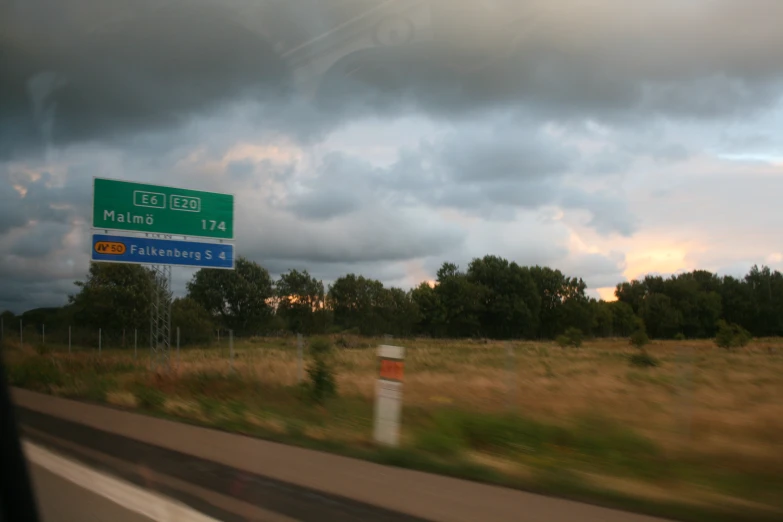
<box><xmin>374</xmin><ymin>344</ymin><xmax>405</xmax><ymax>446</ymax></box>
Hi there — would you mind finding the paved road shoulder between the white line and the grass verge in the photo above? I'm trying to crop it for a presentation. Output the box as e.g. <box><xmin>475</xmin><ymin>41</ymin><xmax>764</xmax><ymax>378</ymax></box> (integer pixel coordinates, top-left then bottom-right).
<box><xmin>13</xmin><ymin>390</ymin><xmax>662</xmax><ymax>522</ymax></box>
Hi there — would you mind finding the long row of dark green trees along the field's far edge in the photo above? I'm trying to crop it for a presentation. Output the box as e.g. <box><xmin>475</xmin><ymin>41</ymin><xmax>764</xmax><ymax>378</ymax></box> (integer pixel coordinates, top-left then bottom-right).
<box><xmin>3</xmin><ymin>255</ymin><xmax>783</xmax><ymax>343</ymax></box>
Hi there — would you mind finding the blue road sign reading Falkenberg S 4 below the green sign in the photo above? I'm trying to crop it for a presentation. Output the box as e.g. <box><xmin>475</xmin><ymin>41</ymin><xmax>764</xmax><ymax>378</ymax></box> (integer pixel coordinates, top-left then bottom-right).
<box><xmin>91</xmin><ymin>234</ymin><xmax>234</xmax><ymax>270</ymax></box>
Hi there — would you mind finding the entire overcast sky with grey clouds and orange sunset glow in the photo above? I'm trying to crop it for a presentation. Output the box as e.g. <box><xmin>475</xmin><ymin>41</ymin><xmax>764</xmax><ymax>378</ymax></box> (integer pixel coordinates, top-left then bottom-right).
<box><xmin>0</xmin><ymin>0</ymin><xmax>783</xmax><ymax>312</ymax></box>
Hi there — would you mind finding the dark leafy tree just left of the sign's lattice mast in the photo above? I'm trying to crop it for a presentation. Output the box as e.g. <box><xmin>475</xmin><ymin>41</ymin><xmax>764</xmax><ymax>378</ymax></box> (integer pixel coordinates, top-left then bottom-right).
<box><xmin>68</xmin><ymin>263</ymin><xmax>156</xmax><ymax>330</ymax></box>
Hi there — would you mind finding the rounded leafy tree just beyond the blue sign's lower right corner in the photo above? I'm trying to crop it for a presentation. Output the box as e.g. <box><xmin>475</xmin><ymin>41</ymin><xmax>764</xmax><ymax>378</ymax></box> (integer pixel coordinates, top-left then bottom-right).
<box><xmin>187</xmin><ymin>257</ymin><xmax>274</xmax><ymax>333</ymax></box>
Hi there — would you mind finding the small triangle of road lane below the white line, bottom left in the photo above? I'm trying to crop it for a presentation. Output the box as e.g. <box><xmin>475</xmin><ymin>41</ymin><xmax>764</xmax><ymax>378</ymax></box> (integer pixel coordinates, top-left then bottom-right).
<box><xmin>30</xmin><ymin>464</ymin><xmax>152</xmax><ymax>522</ymax></box>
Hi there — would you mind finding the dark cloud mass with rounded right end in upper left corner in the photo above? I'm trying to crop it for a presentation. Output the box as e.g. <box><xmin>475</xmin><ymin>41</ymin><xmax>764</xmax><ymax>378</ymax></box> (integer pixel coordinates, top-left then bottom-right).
<box><xmin>0</xmin><ymin>0</ymin><xmax>285</xmax><ymax>154</ymax></box>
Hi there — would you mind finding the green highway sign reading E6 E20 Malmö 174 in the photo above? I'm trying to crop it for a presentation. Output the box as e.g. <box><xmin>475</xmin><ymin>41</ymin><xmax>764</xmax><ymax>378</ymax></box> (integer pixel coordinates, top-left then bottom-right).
<box><xmin>92</xmin><ymin>178</ymin><xmax>234</xmax><ymax>239</ymax></box>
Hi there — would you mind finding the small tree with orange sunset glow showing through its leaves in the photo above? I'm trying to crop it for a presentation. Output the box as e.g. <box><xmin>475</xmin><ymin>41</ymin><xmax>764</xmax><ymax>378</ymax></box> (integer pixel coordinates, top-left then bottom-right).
<box><xmin>275</xmin><ymin>270</ymin><xmax>326</xmax><ymax>334</ymax></box>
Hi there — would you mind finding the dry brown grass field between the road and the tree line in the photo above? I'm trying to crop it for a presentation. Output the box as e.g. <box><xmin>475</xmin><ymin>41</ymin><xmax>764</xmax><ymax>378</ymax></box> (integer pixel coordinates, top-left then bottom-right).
<box><xmin>7</xmin><ymin>336</ymin><xmax>783</xmax><ymax>519</ymax></box>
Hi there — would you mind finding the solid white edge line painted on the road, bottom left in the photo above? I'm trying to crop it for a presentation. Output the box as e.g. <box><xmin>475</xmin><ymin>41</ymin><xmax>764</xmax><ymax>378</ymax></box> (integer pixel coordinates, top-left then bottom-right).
<box><xmin>22</xmin><ymin>440</ymin><xmax>218</xmax><ymax>522</ymax></box>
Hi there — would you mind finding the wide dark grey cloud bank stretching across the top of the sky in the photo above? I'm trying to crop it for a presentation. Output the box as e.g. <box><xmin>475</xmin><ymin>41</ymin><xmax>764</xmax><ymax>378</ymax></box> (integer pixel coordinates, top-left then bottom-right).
<box><xmin>6</xmin><ymin>0</ymin><xmax>783</xmax><ymax>155</ymax></box>
